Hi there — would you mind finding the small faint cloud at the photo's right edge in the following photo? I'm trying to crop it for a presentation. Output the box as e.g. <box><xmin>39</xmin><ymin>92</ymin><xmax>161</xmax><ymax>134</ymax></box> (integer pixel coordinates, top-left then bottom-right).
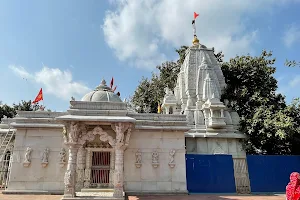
<box><xmin>283</xmin><ymin>24</ymin><xmax>300</xmax><ymax>47</ymax></box>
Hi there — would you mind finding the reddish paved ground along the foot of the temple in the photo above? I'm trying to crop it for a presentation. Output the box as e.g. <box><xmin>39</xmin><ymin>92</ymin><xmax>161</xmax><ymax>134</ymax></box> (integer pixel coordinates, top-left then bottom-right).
<box><xmin>0</xmin><ymin>191</ymin><xmax>285</xmax><ymax>200</ymax></box>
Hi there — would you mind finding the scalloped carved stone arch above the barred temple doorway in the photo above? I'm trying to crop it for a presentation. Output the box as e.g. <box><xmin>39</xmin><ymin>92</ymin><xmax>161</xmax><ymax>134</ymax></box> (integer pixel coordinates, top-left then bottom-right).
<box><xmin>78</xmin><ymin>126</ymin><xmax>115</xmax><ymax>146</ymax></box>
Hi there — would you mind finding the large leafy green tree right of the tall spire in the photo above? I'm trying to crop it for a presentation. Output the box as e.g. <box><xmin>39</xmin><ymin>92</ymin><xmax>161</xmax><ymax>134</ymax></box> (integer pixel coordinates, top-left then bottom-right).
<box><xmin>222</xmin><ymin>51</ymin><xmax>294</xmax><ymax>154</ymax></box>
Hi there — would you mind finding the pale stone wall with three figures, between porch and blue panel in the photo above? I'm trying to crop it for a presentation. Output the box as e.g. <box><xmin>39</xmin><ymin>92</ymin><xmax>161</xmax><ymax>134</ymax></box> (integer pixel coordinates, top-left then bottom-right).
<box><xmin>124</xmin><ymin>130</ymin><xmax>187</xmax><ymax>193</ymax></box>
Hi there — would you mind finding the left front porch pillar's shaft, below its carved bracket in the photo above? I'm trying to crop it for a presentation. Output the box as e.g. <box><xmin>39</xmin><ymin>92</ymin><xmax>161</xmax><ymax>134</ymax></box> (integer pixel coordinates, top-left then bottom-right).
<box><xmin>64</xmin><ymin>144</ymin><xmax>78</xmax><ymax>197</ymax></box>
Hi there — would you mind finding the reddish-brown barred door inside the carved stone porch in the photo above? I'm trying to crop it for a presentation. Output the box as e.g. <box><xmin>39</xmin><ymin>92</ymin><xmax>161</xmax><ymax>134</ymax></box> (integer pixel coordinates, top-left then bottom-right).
<box><xmin>91</xmin><ymin>151</ymin><xmax>111</xmax><ymax>188</ymax></box>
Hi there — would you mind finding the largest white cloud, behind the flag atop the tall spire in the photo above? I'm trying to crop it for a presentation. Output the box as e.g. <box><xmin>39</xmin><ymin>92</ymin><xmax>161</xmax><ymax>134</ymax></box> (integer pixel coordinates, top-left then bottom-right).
<box><xmin>102</xmin><ymin>0</ymin><xmax>292</xmax><ymax>68</ymax></box>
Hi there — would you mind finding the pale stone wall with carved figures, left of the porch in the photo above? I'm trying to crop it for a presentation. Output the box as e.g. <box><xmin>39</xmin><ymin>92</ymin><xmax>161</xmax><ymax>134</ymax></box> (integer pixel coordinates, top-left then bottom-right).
<box><xmin>8</xmin><ymin>129</ymin><xmax>66</xmax><ymax>191</ymax></box>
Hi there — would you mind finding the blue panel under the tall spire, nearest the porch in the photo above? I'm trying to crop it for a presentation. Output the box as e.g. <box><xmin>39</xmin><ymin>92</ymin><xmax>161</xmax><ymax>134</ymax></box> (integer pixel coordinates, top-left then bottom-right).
<box><xmin>186</xmin><ymin>154</ymin><xmax>236</xmax><ymax>193</ymax></box>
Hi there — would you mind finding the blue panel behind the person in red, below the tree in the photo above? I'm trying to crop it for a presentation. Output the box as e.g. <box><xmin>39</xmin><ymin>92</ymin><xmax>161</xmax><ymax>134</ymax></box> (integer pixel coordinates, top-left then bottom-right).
<box><xmin>247</xmin><ymin>155</ymin><xmax>300</xmax><ymax>193</ymax></box>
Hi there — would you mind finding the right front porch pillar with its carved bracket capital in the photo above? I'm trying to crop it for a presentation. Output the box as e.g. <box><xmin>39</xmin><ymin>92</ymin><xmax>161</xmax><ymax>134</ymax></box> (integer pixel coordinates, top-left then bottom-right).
<box><xmin>112</xmin><ymin>123</ymin><xmax>131</xmax><ymax>198</ymax></box>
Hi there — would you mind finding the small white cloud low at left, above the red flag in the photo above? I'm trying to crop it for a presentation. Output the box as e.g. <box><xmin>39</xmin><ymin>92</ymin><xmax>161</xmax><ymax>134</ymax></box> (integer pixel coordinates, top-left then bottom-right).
<box><xmin>9</xmin><ymin>65</ymin><xmax>91</xmax><ymax>100</ymax></box>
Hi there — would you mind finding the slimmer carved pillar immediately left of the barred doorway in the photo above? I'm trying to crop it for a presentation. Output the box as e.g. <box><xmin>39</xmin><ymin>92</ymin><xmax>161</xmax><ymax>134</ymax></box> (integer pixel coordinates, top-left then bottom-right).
<box><xmin>76</xmin><ymin>146</ymin><xmax>86</xmax><ymax>191</ymax></box>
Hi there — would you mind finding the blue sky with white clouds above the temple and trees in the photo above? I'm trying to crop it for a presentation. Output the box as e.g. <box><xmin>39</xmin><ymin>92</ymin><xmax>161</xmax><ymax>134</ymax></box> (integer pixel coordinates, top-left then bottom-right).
<box><xmin>0</xmin><ymin>0</ymin><xmax>300</xmax><ymax>111</ymax></box>
